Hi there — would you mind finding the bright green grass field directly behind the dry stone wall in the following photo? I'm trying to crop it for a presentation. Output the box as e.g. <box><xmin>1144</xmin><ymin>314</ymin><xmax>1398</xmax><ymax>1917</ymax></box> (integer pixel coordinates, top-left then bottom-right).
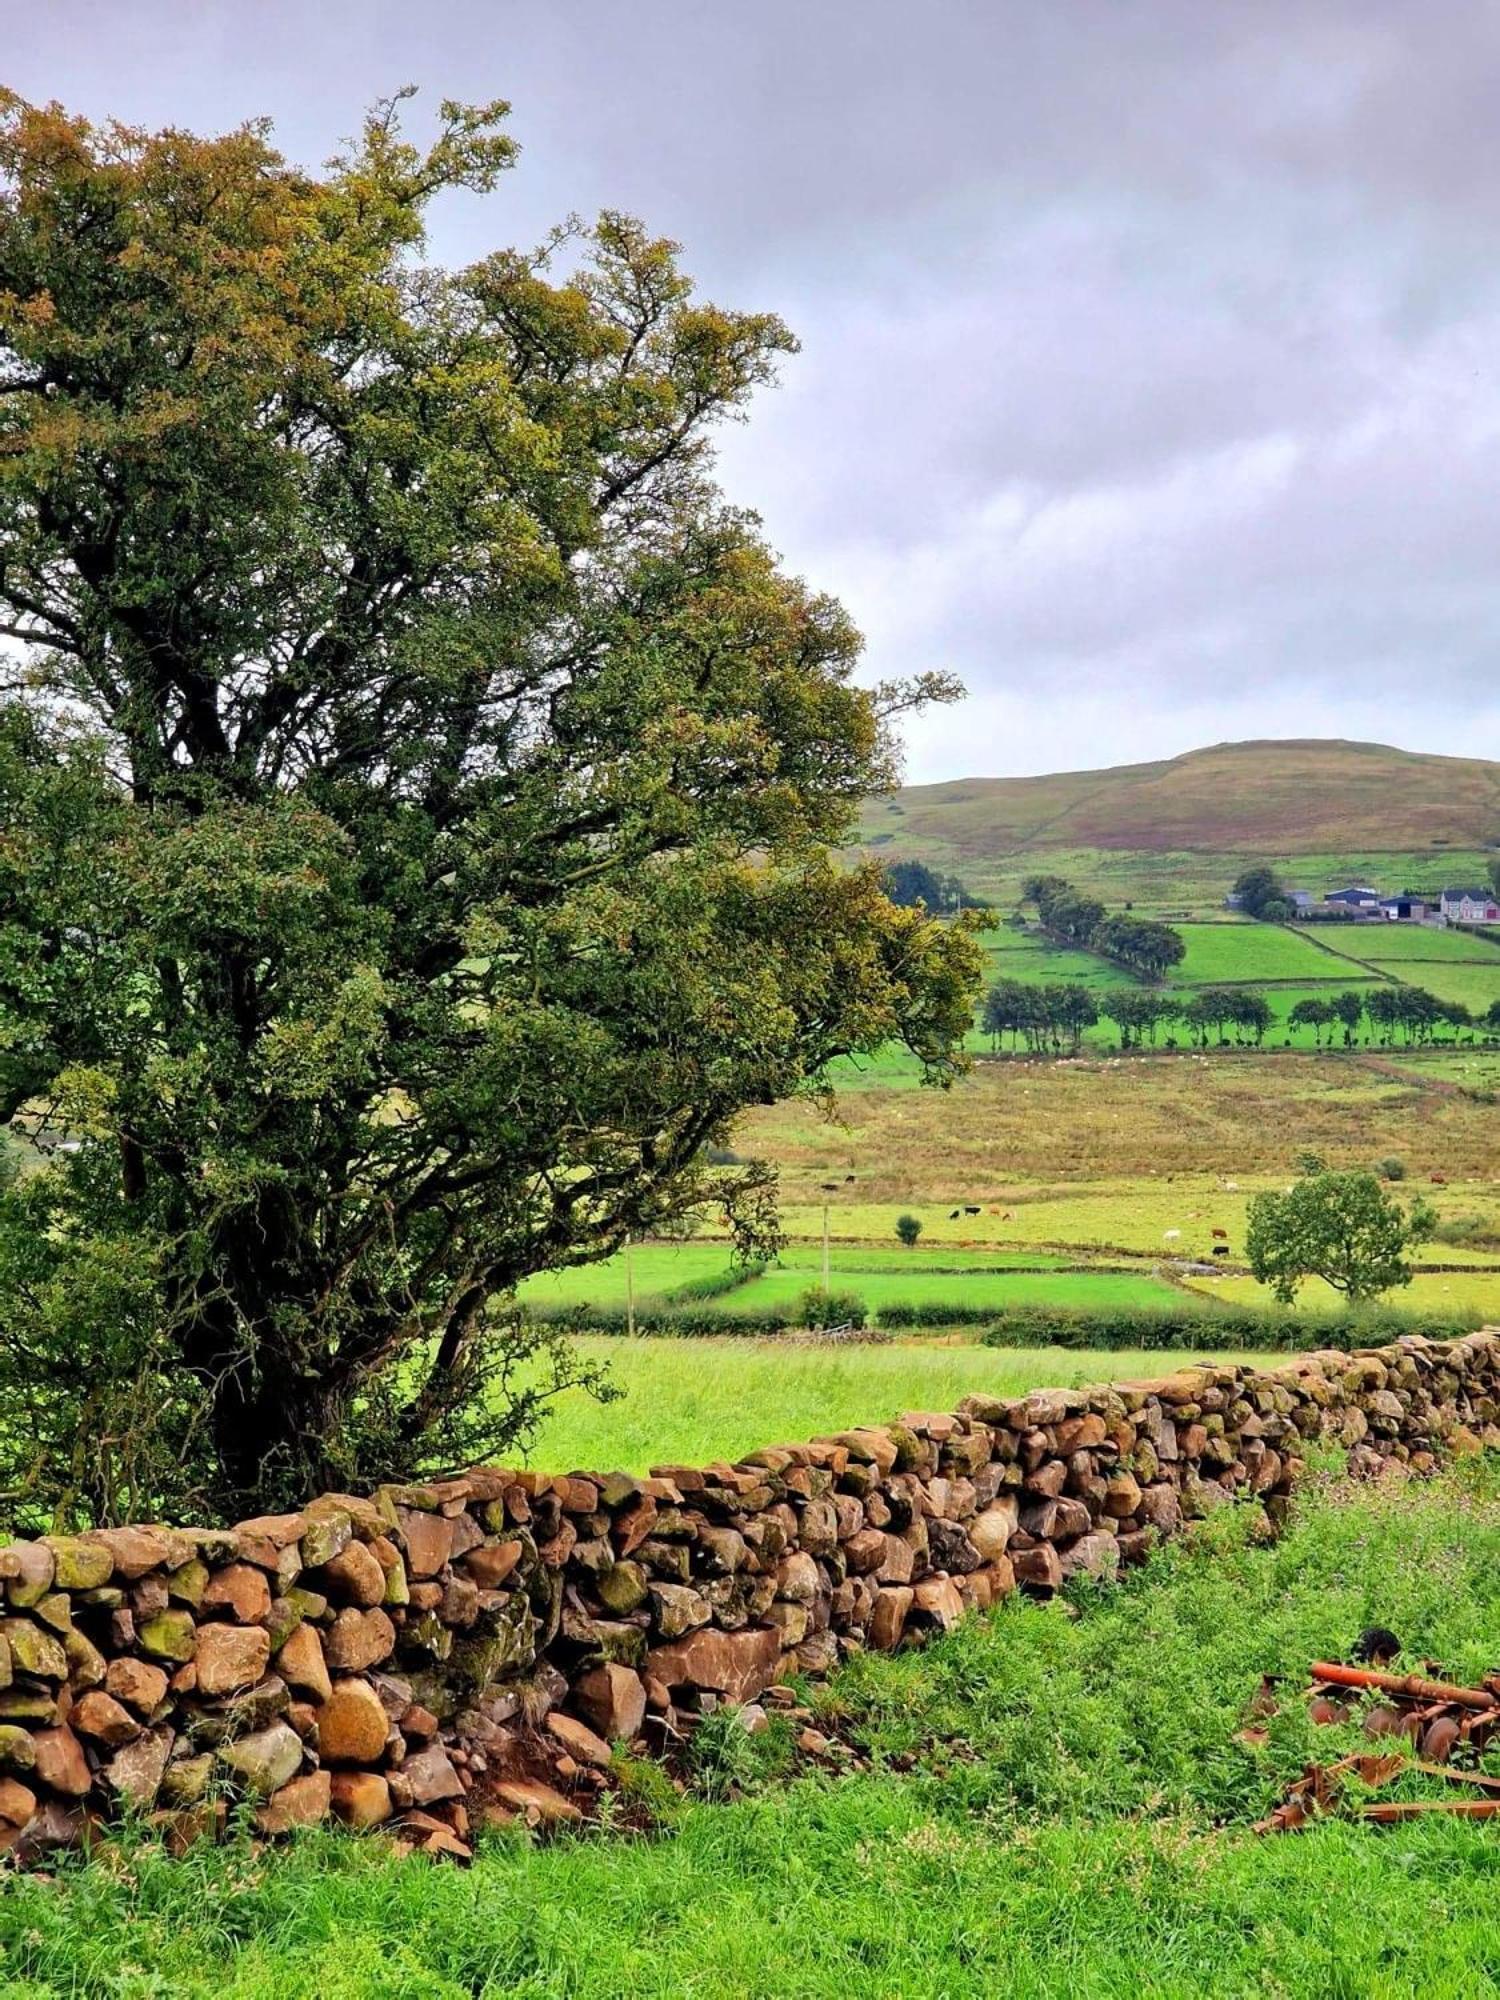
<box><xmin>528</xmin><ymin>1336</ymin><xmax>1284</xmax><ymax>1472</ymax></box>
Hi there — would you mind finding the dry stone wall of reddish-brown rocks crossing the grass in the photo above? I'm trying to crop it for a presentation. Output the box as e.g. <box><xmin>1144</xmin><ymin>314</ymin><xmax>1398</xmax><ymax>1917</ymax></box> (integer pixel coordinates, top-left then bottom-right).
<box><xmin>0</xmin><ymin>1332</ymin><xmax>1500</xmax><ymax>1860</ymax></box>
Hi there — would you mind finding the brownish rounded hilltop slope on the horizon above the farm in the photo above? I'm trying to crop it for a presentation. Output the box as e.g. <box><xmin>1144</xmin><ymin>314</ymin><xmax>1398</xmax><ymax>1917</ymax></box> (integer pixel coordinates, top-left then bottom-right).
<box><xmin>862</xmin><ymin>740</ymin><xmax>1500</xmax><ymax>906</ymax></box>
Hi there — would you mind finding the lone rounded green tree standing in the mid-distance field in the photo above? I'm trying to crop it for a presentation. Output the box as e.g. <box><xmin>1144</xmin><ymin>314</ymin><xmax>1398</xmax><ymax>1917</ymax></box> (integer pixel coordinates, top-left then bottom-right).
<box><xmin>1246</xmin><ymin>1168</ymin><xmax>1436</xmax><ymax>1306</ymax></box>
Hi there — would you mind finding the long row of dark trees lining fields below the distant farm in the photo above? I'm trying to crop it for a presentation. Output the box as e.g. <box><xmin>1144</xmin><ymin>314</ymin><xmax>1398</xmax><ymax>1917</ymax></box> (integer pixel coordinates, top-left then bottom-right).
<box><xmin>980</xmin><ymin>978</ymin><xmax>1500</xmax><ymax>1056</ymax></box>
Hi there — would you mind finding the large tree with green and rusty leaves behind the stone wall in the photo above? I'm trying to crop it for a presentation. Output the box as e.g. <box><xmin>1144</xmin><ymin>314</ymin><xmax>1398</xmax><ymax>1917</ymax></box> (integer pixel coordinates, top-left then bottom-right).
<box><xmin>0</xmin><ymin>96</ymin><xmax>978</xmax><ymax>1514</ymax></box>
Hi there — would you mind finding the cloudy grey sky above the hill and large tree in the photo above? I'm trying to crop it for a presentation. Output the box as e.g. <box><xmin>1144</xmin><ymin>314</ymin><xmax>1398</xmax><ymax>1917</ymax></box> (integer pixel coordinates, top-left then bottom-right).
<box><xmin>0</xmin><ymin>0</ymin><xmax>1500</xmax><ymax>782</ymax></box>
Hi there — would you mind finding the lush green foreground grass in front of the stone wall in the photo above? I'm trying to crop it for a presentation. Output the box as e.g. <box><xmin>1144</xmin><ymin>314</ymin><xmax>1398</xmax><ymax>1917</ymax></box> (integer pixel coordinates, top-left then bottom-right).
<box><xmin>11</xmin><ymin>1472</ymin><xmax>1500</xmax><ymax>2000</ymax></box>
